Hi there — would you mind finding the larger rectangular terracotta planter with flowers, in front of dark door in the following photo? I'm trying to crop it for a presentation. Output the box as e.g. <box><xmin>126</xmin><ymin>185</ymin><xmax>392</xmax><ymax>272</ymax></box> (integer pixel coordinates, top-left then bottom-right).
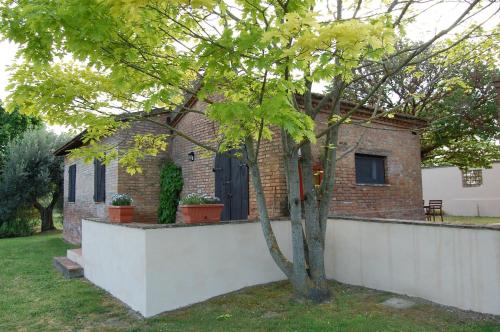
<box><xmin>179</xmin><ymin>194</ymin><xmax>224</xmax><ymax>224</ymax></box>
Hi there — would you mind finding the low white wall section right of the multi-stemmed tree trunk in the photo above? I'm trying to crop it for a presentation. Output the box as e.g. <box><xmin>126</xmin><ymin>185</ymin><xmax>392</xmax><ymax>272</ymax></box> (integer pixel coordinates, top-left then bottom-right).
<box><xmin>325</xmin><ymin>220</ymin><xmax>500</xmax><ymax>315</ymax></box>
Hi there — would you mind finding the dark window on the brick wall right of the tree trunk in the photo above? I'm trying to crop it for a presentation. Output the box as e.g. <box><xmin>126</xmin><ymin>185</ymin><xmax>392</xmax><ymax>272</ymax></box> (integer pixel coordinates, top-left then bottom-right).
<box><xmin>355</xmin><ymin>153</ymin><xmax>386</xmax><ymax>184</ymax></box>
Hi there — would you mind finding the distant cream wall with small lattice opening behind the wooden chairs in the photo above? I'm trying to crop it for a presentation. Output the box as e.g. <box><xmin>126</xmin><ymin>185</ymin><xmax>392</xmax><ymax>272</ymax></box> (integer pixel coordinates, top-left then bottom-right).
<box><xmin>422</xmin><ymin>162</ymin><xmax>500</xmax><ymax>217</ymax></box>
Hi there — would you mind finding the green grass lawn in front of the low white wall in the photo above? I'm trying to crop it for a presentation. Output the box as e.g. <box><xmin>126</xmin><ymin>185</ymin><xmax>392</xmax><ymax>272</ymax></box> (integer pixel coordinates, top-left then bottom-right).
<box><xmin>0</xmin><ymin>233</ymin><xmax>500</xmax><ymax>331</ymax></box>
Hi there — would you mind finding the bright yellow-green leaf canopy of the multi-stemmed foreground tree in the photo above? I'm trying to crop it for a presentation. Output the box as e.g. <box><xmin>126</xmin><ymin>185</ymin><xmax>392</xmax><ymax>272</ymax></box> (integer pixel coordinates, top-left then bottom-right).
<box><xmin>1</xmin><ymin>0</ymin><xmax>498</xmax><ymax>172</ymax></box>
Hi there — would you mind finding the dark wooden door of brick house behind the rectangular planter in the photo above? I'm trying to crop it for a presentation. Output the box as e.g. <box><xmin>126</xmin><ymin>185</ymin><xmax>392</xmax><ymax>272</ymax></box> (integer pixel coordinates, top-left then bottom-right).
<box><xmin>214</xmin><ymin>152</ymin><xmax>248</xmax><ymax>220</ymax></box>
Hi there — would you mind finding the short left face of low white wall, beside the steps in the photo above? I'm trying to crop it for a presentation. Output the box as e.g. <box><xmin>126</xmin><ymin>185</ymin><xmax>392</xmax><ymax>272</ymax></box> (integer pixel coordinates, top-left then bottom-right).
<box><xmin>82</xmin><ymin>220</ymin><xmax>146</xmax><ymax>314</ymax></box>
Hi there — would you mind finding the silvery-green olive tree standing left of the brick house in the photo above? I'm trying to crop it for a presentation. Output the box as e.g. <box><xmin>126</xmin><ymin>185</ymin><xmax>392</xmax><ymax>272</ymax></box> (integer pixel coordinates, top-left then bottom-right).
<box><xmin>0</xmin><ymin>128</ymin><xmax>66</xmax><ymax>232</ymax></box>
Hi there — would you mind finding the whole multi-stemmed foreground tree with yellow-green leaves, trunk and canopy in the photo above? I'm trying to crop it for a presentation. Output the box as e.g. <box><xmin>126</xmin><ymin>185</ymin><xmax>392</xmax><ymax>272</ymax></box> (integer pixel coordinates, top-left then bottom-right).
<box><xmin>0</xmin><ymin>0</ymin><xmax>495</xmax><ymax>301</ymax></box>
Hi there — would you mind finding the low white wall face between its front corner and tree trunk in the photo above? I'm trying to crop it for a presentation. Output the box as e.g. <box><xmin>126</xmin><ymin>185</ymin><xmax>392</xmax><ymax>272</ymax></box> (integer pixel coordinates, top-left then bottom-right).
<box><xmin>143</xmin><ymin>221</ymin><xmax>291</xmax><ymax>317</ymax></box>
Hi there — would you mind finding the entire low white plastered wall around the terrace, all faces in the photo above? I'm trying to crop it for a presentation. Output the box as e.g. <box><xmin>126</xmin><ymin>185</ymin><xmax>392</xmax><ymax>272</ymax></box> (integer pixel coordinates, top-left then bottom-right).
<box><xmin>82</xmin><ymin>219</ymin><xmax>500</xmax><ymax>317</ymax></box>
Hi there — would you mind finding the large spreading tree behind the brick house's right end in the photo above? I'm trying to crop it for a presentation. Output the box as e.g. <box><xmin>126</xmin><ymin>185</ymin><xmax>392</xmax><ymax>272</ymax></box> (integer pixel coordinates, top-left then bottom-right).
<box><xmin>346</xmin><ymin>39</ymin><xmax>500</xmax><ymax>168</ymax></box>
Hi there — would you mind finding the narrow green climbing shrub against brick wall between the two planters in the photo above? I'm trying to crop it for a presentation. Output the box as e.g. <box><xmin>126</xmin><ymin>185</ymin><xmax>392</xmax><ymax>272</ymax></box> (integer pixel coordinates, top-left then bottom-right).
<box><xmin>158</xmin><ymin>161</ymin><xmax>184</xmax><ymax>224</ymax></box>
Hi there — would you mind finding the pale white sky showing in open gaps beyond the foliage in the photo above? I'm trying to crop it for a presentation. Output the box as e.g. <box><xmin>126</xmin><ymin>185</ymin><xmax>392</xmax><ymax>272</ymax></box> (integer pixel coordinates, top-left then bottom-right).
<box><xmin>0</xmin><ymin>1</ymin><xmax>500</xmax><ymax>132</ymax></box>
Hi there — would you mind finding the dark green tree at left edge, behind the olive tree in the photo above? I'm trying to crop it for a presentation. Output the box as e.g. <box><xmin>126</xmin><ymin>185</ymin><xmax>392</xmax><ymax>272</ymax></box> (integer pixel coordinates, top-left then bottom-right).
<box><xmin>0</xmin><ymin>101</ymin><xmax>41</xmax><ymax>173</ymax></box>
